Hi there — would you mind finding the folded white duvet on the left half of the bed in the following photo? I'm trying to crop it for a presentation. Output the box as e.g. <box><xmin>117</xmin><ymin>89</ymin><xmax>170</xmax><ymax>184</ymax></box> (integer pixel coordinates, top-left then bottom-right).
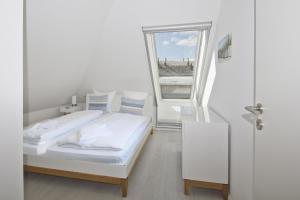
<box><xmin>23</xmin><ymin>110</ymin><xmax>103</xmax><ymax>145</ymax></box>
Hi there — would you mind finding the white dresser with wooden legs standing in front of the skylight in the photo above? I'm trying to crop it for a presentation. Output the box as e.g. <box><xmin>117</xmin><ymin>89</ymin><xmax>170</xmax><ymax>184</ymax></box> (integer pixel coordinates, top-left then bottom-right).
<box><xmin>182</xmin><ymin>107</ymin><xmax>229</xmax><ymax>199</ymax></box>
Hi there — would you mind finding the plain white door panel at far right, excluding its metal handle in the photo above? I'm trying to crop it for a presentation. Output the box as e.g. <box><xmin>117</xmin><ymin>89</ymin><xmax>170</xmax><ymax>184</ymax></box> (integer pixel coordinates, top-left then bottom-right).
<box><xmin>254</xmin><ymin>0</ymin><xmax>300</xmax><ymax>200</ymax></box>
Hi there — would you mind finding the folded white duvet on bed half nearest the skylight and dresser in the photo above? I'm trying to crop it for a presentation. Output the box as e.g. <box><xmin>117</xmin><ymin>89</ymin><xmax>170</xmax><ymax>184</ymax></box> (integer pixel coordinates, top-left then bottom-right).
<box><xmin>57</xmin><ymin>113</ymin><xmax>148</xmax><ymax>151</ymax></box>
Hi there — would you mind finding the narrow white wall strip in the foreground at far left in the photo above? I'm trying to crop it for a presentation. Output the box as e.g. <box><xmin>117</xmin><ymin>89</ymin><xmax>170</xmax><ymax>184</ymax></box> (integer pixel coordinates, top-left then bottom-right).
<box><xmin>0</xmin><ymin>0</ymin><xmax>23</xmax><ymax>200</ymax></box>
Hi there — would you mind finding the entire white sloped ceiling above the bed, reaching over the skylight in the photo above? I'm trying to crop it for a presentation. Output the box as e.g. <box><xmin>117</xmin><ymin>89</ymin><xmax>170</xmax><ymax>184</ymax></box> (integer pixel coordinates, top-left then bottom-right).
<box><xmin>24</xmin><ymin>0</ymin><xmax>221</xmax><ymax>112</ymax></box>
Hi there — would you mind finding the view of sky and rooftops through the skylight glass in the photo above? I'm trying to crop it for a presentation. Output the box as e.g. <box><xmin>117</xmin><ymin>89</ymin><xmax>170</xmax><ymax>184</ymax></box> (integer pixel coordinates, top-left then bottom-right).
<box><xmin>154</xmin><ymin>31</ymin><xmax>200</xmax><ymax>99</ymax></box>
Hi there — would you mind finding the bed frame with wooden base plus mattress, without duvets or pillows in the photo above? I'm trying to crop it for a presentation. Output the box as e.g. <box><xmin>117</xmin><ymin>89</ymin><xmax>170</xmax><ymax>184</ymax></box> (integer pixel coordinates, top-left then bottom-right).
<box><xmin>24</xmin><ymin>113</ymin><xmax>152</xmax><ymax>197</ymax></box>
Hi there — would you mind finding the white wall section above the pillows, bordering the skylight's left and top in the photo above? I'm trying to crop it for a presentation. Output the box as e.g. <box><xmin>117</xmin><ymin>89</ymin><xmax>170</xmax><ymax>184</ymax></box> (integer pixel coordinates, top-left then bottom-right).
<box><xmin>81</xmin><ymin>0</ymin><xmax>220</xmax><ymax>94</ymax></box>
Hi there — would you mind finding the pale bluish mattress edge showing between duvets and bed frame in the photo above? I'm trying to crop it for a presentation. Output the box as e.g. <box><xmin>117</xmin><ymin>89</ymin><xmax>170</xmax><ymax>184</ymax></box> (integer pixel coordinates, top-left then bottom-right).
<box><xmin>32</xmin><ymin>115</ymin><xmax>152</xmax><ymax>164</ymax></box>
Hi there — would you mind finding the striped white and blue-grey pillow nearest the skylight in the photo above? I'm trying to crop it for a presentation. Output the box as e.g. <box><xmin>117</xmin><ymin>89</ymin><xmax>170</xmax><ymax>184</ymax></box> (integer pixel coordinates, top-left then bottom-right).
<box><xmin>120</xmin><ymin>91</ymin><xmax>148</xmax><ymax>115</ymax></box>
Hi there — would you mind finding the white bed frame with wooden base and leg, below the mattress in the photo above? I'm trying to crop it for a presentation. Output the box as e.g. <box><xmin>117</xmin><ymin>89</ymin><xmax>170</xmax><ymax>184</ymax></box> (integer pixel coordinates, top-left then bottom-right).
<box><xmin>24</xmin><ymin>126</ymin><xmax>153</xmax><ymax>197</ymax></box>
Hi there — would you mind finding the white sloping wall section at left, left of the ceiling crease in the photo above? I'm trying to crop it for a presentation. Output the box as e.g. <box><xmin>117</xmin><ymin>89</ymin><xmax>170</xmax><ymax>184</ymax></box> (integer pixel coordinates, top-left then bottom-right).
<box><xmin>24</xmin><ymin>0</ymin><xmax>114</xmax><ymax>113</ymax></box>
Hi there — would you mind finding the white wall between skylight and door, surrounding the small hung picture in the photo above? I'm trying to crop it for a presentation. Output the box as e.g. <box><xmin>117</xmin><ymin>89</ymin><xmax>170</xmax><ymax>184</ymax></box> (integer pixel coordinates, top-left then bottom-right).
<box><xmin>210</xmin><ymin>0</ymin><xmax>254</xmax><ymax>200</ymax></box>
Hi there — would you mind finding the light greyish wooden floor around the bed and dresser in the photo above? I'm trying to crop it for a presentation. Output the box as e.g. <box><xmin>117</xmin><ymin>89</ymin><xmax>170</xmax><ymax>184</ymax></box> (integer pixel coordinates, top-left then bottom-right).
<box><xmin>24</xmin><ymin>131</ymin><xmax>222</xmax><ymax>200</ymax></box>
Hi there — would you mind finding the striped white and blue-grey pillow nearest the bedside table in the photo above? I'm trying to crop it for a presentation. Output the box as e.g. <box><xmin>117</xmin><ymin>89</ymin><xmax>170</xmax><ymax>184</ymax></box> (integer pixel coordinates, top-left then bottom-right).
<box><xmin>86</xmin><ymin>89</ymin><xmax>116</xmax><ymax>112</ymax></box>
